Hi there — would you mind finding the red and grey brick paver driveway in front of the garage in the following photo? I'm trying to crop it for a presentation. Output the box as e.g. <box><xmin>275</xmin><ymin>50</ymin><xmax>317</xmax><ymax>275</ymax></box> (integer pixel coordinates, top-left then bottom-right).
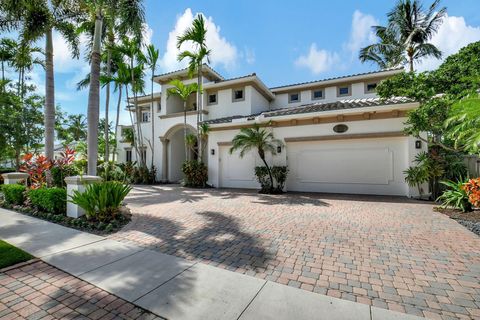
<box><xmin>112</xmin><ymin>186</ymin><xmax>480</xmax><ymax>319</ymax></box>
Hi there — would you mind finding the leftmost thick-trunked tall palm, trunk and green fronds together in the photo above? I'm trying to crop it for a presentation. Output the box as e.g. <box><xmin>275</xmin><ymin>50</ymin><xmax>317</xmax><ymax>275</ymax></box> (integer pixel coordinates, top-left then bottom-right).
<box><xmin>0</xmin><ymin>0</ymin><xmax>83</xmax><ymax>165</ymax></box>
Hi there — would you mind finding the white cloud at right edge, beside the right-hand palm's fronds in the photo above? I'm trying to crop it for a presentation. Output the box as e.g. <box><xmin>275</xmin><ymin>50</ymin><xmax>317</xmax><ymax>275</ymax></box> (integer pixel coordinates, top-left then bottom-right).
<box><xmin>418</xmin><ymin>15</ymin><xmax>480</xmax><ymax>71</ymax></box>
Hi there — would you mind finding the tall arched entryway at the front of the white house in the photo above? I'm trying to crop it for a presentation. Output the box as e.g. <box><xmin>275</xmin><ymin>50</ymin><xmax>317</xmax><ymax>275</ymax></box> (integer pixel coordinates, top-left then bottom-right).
<box><xmin>160</xmin><ymin>123</ymin><xmax>196</xmax><ymax>182</ymax></box>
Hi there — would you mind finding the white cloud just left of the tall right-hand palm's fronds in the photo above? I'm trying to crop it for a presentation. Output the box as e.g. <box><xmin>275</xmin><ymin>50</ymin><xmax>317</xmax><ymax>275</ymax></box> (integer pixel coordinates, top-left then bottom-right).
<box><xmin>345</xmin><ymin>10</ymin><xmax>379</xmax><ymax>56</ymax></box>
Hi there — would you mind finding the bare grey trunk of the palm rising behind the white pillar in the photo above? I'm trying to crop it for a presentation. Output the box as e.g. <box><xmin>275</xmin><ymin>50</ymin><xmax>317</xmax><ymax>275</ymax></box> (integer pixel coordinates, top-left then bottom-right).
<box><xmin>87</xmin><ymin>9</ymin><xmax>103</xmax><ymax>176</ymax></box>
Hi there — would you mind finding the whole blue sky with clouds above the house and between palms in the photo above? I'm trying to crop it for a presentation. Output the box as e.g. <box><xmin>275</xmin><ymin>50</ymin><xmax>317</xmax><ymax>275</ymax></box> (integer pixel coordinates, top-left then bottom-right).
<box><xmin>11</xmin><ymin>0</ymin><xmax>480</xmax><ymax>124</ymax></box>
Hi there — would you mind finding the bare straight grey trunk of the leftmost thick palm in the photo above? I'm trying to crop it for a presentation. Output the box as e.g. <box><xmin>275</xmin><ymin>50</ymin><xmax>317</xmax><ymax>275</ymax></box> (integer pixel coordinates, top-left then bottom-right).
<box><xmin>44</xmin><ymin>29</ymin><xmax>55</xmax><ymax>160</ymax></box>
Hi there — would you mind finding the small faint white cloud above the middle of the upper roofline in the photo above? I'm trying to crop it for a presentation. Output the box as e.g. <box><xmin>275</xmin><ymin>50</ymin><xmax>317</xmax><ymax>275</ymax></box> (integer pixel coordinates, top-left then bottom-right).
<box><xmin>295</xmin><ymin>43</ymin><xmax>340</xmax><ymax>74</ymax></box>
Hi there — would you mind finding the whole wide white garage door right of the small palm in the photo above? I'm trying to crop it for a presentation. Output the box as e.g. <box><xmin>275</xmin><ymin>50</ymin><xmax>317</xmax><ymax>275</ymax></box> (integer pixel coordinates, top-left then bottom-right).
<box><xmin>286</xmin><ymin>137</ymin><xmax>408</xmax><ymax>195</ymax></box>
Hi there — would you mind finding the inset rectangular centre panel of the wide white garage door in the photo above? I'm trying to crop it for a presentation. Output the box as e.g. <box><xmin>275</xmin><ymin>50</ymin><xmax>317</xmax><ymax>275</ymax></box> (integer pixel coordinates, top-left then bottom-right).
<box><xmin>294</xmin><ymin>148</ymin><xmax>393</xmax><ymax>184</ymax></box>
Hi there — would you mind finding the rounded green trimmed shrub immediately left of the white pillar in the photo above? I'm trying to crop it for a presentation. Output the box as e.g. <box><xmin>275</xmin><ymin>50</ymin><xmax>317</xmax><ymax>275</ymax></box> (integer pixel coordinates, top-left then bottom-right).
<box><xmin>28</xmin><ymin>188</ymin><xmax>67</xmax><ymax>215</ymax></box>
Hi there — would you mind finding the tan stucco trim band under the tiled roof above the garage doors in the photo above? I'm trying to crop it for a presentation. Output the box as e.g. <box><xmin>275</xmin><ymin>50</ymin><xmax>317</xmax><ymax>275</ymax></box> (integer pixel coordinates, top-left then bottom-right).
<box><xmin>210</xmin><ymin>110</ymin><xmax>408</xmax><ymax>131</ymax></box>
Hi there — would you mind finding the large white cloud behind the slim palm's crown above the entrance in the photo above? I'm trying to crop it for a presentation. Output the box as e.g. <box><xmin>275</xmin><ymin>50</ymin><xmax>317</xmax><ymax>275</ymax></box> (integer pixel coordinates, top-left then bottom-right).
<box><xmin>160</xmin><ymin>8</ymin><xmax>239</xmax><ymax>71</ymax></box>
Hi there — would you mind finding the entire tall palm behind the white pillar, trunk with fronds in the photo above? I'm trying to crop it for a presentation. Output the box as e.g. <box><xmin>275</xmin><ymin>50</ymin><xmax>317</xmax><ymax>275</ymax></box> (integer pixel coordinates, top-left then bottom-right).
<box><xmin>81</xmin><ymin>0</ymin><xmax>145</xmax><ymax>175</ymax></box>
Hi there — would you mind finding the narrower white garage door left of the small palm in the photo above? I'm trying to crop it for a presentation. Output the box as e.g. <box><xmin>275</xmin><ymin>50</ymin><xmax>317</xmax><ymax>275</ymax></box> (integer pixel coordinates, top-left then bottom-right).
<box><xmin>220</xmin><ymin>146</ymin><xmax>262</xmax><ymax>189</ymax></box>
